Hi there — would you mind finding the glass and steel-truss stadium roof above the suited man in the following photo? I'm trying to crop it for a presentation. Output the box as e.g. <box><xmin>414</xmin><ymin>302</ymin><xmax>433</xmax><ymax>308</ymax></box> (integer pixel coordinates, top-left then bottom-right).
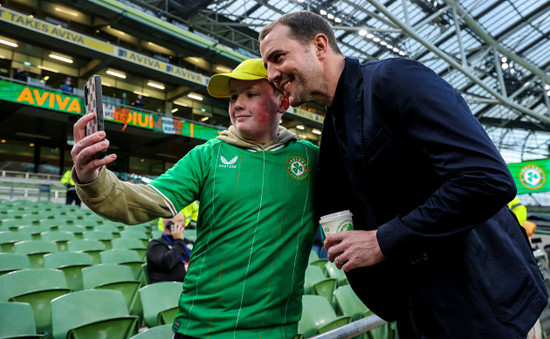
<box><xmin>132</xmin><ymin>0</ymin><xmax>550</xmax><ymax>162</ymax></box>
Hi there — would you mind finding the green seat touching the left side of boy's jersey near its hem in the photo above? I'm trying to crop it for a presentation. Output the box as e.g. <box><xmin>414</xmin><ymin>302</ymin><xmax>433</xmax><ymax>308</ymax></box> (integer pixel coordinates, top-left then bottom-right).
<box><xmin>139</xmin><ymin>281</ymin><xmax>182</xmax><ymax>327</ymax></box>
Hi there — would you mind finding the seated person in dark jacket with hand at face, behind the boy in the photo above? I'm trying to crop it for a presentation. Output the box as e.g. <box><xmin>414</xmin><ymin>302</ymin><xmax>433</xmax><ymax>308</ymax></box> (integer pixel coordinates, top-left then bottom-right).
<box><xmin>147</xmin><ymin>213</ymin><xmax>191</xmax><ymax>283</ymax></box>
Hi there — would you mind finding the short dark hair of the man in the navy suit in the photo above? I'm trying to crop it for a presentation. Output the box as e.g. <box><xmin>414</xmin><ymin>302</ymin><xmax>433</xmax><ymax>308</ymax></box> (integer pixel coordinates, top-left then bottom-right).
<box><xmin>258</xmin><ymin>11</ymin><xmax>342</xmax><ymax>54</ymax></box>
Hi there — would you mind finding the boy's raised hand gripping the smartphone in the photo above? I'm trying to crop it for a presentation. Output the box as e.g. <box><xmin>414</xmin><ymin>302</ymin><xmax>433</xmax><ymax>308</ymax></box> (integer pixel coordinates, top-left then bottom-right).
<box><xmin>71</xmin><ymin>114</ymin><xmax>116</xmax><ymax>184</ymax></box>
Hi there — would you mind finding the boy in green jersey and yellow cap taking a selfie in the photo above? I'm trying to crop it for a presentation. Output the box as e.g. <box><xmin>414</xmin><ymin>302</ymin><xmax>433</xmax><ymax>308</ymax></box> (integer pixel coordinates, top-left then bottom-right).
<box><xmin>71</xmin><ymin>59</ymin><xmax>318</xmax><ymax>339</ymax></box>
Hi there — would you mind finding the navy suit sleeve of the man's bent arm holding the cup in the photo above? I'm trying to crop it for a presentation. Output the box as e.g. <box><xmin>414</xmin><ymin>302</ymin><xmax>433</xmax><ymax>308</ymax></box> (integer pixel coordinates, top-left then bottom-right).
<box><xmin>377</xmin><ymin>60</ymin><xmax>516</xmax><ymax>257</ymax></box>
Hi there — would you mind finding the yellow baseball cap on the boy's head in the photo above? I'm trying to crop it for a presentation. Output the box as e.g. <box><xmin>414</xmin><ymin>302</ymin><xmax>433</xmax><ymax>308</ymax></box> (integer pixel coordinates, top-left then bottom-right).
<box><xmin>207</xmin><ymin>59</ymin><xmax>267</xmax><ymax>98</ymax></box>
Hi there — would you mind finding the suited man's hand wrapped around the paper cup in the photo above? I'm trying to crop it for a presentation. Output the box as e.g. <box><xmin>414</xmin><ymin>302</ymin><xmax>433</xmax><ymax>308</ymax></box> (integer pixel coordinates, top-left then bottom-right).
<box><xmin>324</xmin><ymin>231</ymin><xmax>384</xmax><ymax>272</ymax></box>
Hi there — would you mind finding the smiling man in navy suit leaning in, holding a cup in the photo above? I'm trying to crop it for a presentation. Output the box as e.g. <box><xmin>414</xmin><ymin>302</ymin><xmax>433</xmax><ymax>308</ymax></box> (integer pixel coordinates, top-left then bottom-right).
<box><xmin>259</xmin><ymin>12</ymin><xmax>548</xmax><ymax>338</ymax></box>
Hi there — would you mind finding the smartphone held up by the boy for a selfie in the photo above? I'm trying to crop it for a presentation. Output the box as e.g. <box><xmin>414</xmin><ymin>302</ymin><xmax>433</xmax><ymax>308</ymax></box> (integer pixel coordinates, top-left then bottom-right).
<box><xmin>84</xmin><ymin>75</ymin><xmax>107</xmax><ymax>159</ymax></box>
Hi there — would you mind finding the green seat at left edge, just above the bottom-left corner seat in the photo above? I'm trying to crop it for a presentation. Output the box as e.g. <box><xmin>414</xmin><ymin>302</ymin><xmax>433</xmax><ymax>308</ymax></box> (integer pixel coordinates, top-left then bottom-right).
<box><xmin>0</xmin><ymin>268</ymin><xmax>71</xmax><ymax>333</ymax></box>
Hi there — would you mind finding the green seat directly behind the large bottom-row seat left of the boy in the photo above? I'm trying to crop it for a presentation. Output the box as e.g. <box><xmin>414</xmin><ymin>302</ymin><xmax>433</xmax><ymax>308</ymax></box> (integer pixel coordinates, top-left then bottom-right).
<box><xmin>82</xmin><ymin>264</ymin><xmax>141</xmax><ymax>315</ymax></box>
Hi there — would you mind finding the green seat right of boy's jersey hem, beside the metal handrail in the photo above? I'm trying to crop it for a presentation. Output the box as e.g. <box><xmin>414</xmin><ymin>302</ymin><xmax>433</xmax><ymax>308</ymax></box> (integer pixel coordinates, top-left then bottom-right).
<box><xmin>298</xmin><ymin>295</ymin><xmax>351</xmax><ymax>338</ymax></box>
